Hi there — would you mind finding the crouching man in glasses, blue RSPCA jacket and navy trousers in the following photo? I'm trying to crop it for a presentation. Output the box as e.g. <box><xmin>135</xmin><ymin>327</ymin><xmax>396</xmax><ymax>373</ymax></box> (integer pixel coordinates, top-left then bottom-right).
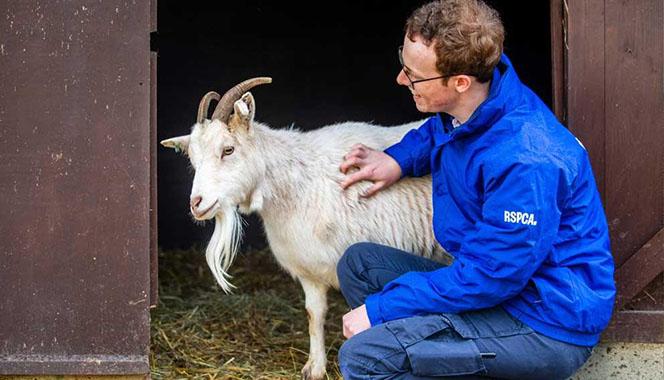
<box><xmin>337</xmin><ymin>0</ymin><xmax>615</xmax><ymax>379</ymax></box>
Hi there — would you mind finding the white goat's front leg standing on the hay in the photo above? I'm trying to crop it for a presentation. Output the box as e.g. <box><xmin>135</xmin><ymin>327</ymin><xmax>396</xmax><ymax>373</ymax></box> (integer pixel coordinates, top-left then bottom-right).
<box><xmin>300</xmin><ymin>278</ymin><xmax>328</xmax><ymax>380</ymax></box>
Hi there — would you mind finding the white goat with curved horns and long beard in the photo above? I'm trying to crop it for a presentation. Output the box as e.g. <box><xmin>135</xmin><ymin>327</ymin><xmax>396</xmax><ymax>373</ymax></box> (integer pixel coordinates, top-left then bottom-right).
<box><xmin>161</xmin><ymin>78</ymin><xmax>448</xmax><ymax>379</ymax></box>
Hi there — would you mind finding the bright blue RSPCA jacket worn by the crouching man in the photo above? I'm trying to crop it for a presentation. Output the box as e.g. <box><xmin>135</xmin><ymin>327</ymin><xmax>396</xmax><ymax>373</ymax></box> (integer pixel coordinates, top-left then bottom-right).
<box><xmin>366</xmin><ymin>55</ymin><xmax>615</xmax><ymax>346</ymax></box>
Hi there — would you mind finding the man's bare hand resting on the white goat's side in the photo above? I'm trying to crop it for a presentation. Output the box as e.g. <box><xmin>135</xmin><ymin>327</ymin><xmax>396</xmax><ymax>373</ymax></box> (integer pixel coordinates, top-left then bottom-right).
<box><xmin>339</xmin><ymin>144</ymin><xmax>401</xmax><ymax>197</ymax></box>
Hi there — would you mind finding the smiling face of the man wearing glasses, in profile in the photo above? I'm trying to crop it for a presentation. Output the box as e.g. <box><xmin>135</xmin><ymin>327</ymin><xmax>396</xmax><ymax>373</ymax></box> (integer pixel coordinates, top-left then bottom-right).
<box><xmin>397</xmin><ymin>35</ymin><xmax>459</xmax><ymax>113</ymax></box>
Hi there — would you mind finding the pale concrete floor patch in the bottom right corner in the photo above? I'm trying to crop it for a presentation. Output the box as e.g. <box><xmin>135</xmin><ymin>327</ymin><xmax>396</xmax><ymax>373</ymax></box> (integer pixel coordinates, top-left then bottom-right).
<box><xmin>572</xmin><ymin>343</ymin><xmax>664</xmax><ymax>380</ymax></box>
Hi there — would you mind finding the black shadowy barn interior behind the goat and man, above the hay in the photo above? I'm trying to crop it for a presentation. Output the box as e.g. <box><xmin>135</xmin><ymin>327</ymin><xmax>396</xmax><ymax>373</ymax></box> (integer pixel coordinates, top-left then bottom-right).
<box><xmin>153</xmin><ymin>0</ymin><xmax>551</xmax><ymax>249</ymax></box>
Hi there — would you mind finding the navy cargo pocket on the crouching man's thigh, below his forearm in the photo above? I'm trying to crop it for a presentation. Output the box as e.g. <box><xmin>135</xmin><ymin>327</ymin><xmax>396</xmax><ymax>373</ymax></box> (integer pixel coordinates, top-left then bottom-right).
<box><xmin>386</xmin><ymin>315</ymin><xmax>486</xmax><ymax>376</ymax></box>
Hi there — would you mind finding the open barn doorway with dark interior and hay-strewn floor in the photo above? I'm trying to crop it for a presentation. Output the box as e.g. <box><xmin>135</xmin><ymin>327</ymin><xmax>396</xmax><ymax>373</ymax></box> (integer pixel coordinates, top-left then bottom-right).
<box><xmin>152</xmin><ymin>0</ymin><xmax>552</xmax><ymax>378</ymax></box>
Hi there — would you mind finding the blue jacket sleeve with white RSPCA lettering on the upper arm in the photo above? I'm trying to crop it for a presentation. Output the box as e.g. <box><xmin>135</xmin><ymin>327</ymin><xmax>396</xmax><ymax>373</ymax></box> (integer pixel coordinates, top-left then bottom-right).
<box><xmin>365</xmin><ymin>163</ymin><xmax>564</xmax><ymax>325</ymax></box>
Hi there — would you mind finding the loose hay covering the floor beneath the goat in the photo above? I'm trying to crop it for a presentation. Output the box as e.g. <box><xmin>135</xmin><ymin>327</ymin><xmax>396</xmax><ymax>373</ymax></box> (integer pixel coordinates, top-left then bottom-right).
<box><xmin>150</xmin><ymin>248</ymin><xmax>347</xmax><ymax>379</ymax></box>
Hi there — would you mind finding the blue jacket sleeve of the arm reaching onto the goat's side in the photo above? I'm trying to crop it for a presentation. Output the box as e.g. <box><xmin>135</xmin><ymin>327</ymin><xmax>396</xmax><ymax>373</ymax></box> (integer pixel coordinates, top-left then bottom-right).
<box><xmin>384</xmin><ymin>116</ymin><xmax>435</xmax><ymax>177</ymax></box>
